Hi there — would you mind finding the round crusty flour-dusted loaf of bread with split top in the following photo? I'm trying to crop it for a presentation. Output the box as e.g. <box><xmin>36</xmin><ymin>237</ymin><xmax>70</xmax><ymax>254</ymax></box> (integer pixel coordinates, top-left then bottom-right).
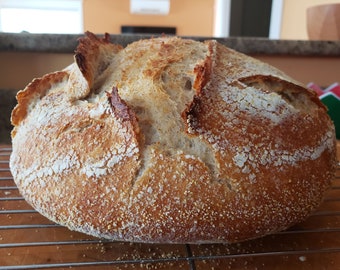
<box><xmin>10</xmin><ymin>33</ymin><xmax>336</xmax><ymax>243</ymax></box>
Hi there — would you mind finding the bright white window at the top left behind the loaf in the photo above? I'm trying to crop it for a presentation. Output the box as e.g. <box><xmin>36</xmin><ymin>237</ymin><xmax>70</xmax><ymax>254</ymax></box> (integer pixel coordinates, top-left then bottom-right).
<box><xmin>0</xmin><ymin>0</ymin><xmax>83</xmax><ymax>34</ymax></box>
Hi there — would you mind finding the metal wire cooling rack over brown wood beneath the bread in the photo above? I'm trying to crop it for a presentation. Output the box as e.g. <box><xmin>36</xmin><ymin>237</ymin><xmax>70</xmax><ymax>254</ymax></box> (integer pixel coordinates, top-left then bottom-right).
<box><xmin>0</xmin><ymin>145</ymin><xmax>340</xmax><ymax>270</ymax></box>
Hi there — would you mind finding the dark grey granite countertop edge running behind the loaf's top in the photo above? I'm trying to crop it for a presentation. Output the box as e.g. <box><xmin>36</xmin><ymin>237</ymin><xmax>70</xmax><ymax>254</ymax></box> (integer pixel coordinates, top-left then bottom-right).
<box><xmin>0</xmin><ymin>33</ymin><xmax>340</xmax><ymax>57</ymax></box>
